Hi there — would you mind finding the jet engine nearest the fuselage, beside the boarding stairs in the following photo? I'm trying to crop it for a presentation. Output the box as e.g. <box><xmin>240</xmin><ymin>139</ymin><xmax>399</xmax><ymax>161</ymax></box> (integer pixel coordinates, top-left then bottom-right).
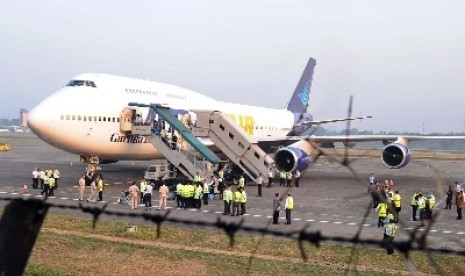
<box><xmin>274</xmin><ymin>141</ymin><xmax>313</xmax><ymax>172</ymax></box>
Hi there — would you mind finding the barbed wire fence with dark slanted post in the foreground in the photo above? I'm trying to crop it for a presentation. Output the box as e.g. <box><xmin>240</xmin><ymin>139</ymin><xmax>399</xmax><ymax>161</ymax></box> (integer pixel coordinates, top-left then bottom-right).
<box><xmin>0</xmin><ymin>144</ymin><xmax>465</xmax><ymax>275</ymax></box>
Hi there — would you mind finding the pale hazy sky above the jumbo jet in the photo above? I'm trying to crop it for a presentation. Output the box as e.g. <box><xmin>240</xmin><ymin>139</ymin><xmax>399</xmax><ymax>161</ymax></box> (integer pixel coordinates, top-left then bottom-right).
<box><xmin>0</xmin><ymin>0</ymin><xmax>465</xmax><ymax>133</ymax></box>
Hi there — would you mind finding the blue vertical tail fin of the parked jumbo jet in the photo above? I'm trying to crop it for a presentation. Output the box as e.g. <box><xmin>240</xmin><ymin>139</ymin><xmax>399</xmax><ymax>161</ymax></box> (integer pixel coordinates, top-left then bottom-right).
<box><xmin>286</xmin><ymin>58</ymin><xmax>316</xmax><ymax>115</ymax></box>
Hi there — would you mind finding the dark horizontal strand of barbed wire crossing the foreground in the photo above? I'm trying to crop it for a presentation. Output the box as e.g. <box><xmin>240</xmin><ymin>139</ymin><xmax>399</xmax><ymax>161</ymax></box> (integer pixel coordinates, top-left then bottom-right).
<box><xmin>0</xmin><ymin>191</ymin><xmax>465</xmax><ymax>260</ymax></box>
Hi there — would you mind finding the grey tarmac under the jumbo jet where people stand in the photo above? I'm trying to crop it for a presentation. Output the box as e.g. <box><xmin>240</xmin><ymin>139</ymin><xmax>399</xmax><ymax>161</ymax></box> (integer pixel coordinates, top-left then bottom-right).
<box><xmin>0</xmin><ymin>134</ymin><xmax>465</xmax><ymax>253</ymax></box>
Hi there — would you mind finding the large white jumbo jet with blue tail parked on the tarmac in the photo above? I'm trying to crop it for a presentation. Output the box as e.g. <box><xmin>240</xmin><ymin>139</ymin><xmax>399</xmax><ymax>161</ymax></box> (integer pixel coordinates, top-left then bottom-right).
<box><xmin>28</xmin><ymin>58</ymin><xmax>465</xmax><ymax>175</ymax></box>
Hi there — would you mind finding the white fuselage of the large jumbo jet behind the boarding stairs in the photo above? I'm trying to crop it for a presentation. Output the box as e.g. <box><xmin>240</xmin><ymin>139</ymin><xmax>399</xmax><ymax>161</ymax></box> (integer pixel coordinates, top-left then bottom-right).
<box><xmin>28</xmin><ymin>74</ymin><xmax>294</xmax><ymax>160</ymax></box>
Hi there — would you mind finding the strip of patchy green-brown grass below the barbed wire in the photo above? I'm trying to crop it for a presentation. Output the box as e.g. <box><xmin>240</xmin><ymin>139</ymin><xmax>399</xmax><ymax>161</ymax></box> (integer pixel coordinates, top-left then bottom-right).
<box><xmin>15</xmin><ymin>215</ymin><xmax>465</xmax><ymax>275</ymax></box>
